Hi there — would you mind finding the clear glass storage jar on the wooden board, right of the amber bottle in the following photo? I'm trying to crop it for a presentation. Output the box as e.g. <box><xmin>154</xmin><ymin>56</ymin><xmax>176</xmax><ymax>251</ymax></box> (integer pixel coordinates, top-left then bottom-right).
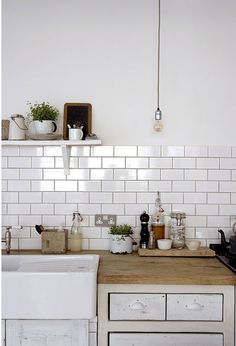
<box><xmin>170</xmin><ymin>211</ymin><xmax>186</xmax><ymax>249</ymax></box>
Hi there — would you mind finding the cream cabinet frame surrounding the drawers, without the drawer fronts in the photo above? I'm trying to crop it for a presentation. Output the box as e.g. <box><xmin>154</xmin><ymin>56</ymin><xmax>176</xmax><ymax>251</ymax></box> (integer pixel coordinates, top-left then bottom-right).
<box><xmin>98</xmin><ymin>284</ymin><xmax>234</xmax><ymax>346</ymax></box>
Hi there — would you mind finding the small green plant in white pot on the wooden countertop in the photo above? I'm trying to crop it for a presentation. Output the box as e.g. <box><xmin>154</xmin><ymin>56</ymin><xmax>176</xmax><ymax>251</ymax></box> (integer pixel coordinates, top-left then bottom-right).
<box><xmin>109</xmin><ymin>224</ymin><xmax>133</xmax><ymax>254</ymax></box>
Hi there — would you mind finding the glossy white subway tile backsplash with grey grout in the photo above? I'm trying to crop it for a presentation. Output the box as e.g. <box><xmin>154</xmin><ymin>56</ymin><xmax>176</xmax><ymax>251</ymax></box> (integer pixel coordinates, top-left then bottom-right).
<box><xmin>2</xmin><ymin>145</ymin><xmax>236</xmax><ymax>249</ymax></box>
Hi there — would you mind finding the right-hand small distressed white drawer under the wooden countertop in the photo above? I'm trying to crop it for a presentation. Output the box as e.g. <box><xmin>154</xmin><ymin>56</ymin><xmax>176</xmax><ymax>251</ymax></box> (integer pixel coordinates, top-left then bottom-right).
<box><xmin>167</xmin><ymin>294</ymin><xmax>223</xmax><ymax>321</ymax></box>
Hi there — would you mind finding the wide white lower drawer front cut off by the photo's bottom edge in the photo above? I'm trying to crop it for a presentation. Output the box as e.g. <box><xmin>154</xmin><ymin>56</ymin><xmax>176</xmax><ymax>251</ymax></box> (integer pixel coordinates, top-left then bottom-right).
<box><xmin>109</xmin><ymin>333</ymin><xmax>223</xmax><ymax>346</ymax></box>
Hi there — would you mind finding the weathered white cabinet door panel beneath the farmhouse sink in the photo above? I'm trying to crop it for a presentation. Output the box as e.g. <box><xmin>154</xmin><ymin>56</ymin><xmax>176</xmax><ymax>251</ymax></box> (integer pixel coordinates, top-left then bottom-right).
<box><xmin>6</xmin><ymin>320</ymin><xmax>88</xmax><ymax>346</ymax></box>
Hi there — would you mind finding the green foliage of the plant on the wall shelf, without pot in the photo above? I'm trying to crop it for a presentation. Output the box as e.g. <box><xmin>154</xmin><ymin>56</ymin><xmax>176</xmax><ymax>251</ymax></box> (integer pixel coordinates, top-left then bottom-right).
<box><xmin>27</xmin><ymin>102</ymin><xmax>59</xmax><ymax>121</ymax></box>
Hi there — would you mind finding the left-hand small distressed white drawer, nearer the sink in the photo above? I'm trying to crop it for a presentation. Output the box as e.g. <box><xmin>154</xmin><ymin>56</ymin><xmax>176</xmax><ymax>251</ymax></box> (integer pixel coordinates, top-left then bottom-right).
<box><xmin>109</xmin><ymin>293</ymin><xmax>166</xmax><ymax>320</ymax></box>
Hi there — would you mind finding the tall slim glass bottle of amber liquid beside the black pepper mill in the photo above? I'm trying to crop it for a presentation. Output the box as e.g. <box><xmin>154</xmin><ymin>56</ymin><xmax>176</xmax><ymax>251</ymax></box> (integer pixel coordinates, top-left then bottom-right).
<box><xmin>151</xmin><ymin>191</ymin><xmax>165</xmax><ymax>247</ymax></box>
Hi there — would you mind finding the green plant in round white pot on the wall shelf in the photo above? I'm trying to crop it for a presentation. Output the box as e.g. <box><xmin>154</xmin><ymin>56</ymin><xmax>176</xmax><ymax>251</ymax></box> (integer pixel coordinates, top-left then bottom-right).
<box><xmin>28</xmin><ymin>102</ymin><xmax>59</xmax><ymax>134</ymax></box>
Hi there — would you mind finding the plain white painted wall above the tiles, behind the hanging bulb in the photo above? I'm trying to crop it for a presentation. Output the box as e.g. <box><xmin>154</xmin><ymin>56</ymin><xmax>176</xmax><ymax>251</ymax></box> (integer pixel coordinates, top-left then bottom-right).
<box><xmin>2</xmin><ymin>0</ymin><xmax>236</xmax><ymax>145</ymax></box>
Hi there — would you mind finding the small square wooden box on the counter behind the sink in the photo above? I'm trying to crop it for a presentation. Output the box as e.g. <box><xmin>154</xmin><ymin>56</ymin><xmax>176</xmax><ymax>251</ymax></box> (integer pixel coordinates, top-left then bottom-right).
<box><xmin>41</xmin><ymin>230</ymin><xmax>68</xmax><ymax>254</ymax></box>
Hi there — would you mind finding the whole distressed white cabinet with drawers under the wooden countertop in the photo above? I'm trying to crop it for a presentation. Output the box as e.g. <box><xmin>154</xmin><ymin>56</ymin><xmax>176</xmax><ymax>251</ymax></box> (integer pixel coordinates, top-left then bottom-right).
<box><xmin>98</xmin><ymin>284</ymin><xmax>234</xmax><ymax>346</ymax></box>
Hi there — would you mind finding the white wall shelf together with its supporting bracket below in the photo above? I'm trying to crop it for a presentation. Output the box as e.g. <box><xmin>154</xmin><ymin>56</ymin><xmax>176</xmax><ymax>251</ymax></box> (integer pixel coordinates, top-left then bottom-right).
<box><xmin>2</xmin><ymin>139</ymin><xmax>102</xmax><ymax>175</ymax></box>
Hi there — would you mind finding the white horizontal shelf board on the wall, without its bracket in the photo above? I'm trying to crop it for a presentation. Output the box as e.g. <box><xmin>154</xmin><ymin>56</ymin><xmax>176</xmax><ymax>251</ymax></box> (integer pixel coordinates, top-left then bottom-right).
<box><xmin>2</xmin><ymin>139</ymin><xmax>102</xmax><ymax>146</ymax></box>
